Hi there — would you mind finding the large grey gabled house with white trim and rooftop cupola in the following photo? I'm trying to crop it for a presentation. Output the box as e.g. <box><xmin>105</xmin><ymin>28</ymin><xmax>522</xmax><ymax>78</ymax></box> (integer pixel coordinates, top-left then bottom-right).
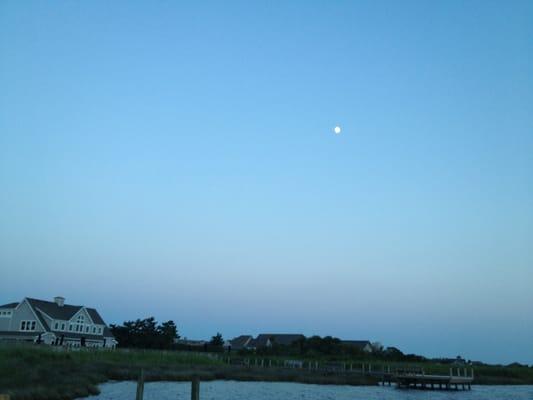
<box><xmin>0</xmin><ymin>296</ymin><xmax>117</xmax><ymax>348</ymax></box>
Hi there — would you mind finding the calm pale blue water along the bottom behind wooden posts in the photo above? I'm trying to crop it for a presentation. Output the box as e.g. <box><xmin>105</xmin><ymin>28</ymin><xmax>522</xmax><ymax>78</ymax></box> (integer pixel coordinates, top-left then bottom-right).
<box><xmin>84</xmin><ymin>381</ymin><xmax>533</xmax><ymax>400</ymax></box>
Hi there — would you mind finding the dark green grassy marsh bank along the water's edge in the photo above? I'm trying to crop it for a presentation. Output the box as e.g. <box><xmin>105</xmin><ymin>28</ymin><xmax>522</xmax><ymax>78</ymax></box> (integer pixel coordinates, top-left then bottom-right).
<box><xmin>0</xmin><ymin>345</ymin><xmax>533</xmax><ymax>400</ymax></box>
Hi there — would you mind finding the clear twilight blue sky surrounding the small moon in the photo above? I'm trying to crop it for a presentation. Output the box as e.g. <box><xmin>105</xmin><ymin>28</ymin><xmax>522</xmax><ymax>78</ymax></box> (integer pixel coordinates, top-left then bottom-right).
<box><xmin>0</xmin><ymin>1</ymin><xmax>533</xmax><ymax>363</ymax></box>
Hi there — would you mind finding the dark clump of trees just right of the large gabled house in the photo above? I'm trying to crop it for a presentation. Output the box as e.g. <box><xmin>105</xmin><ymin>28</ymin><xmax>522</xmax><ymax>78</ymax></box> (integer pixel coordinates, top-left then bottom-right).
<box><xmin>110</xmin><ymin>317</ymin><xmax>179</xmax><ymax>349</ymax></box>
